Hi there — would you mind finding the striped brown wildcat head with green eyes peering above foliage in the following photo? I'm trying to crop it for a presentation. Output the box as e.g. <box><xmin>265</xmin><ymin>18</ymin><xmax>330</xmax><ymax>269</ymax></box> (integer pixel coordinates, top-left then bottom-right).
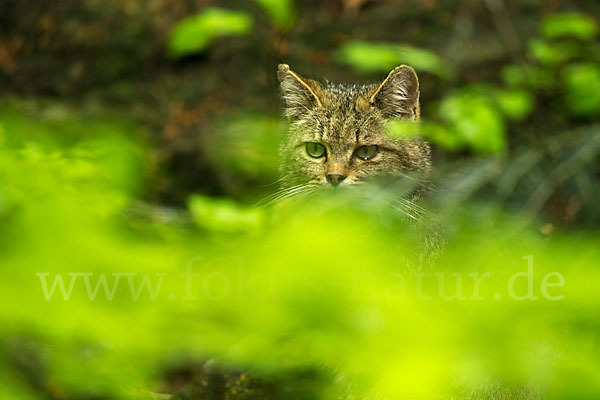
<box><xmin>278</xmin><ymin>65</ymin><xmax>429</xmax><ymax>186</ymax></box>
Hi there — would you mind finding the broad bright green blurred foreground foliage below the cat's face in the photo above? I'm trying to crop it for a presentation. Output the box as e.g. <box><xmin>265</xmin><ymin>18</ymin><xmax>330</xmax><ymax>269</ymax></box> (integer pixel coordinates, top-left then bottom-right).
<box><xmin>0</xmin><ymin>104</ymin><xmax>600</xmax><ymax>399</ymax></box>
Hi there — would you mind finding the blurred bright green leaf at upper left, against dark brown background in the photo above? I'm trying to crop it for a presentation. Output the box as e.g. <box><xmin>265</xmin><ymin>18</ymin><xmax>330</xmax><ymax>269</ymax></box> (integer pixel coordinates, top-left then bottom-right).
<box><xmin>168</xmin><ymin>8</ymin><xmax>252</xmax><ymax>57</ymax></box>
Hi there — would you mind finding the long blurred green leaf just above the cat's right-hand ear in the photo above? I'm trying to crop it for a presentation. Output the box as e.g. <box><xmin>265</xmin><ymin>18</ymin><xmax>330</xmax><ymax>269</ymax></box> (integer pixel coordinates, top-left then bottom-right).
<box><xmin>336</xmin><ymin>41</ymin><xmax>450</xmax><ymax>76</ymax></box>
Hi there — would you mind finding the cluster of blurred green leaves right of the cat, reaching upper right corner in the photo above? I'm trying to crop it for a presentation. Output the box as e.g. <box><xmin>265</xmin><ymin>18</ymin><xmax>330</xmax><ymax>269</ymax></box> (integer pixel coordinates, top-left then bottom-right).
<box><xmin>414</xmin><ymin>13</ymin><xmax>600</xmax><ymax>154</ymax></box>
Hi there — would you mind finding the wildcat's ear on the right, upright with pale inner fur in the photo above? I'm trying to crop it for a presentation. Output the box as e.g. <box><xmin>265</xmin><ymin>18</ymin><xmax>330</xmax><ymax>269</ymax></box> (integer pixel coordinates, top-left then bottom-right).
<box><xmin>369</xmin><ymin>65</ymin><xmax>419</xmax><ymax>119</ymax></box>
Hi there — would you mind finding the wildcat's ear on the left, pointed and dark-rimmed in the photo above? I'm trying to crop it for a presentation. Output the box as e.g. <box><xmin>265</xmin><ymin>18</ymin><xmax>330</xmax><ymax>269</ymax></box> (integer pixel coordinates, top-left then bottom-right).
<box><xmin>277</xmin><ymin>64</ymin><xmax>324</xmax><ymax>120</ymax></box>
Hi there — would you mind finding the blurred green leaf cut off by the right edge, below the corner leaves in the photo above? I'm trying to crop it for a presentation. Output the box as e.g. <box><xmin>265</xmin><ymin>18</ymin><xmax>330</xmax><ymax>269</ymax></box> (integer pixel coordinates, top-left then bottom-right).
<box><xmin>562</xmin><ymin>63</ymin><xmax>600</xmax><ymax>116</ymax></box>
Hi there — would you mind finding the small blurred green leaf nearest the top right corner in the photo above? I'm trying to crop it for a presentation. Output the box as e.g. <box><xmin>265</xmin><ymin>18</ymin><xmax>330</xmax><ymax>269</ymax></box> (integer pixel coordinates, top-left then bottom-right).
<box><xmin>542</xmin><ymin>13</ymin><xmax>598</xmax><ymax>40</ymax></box>
